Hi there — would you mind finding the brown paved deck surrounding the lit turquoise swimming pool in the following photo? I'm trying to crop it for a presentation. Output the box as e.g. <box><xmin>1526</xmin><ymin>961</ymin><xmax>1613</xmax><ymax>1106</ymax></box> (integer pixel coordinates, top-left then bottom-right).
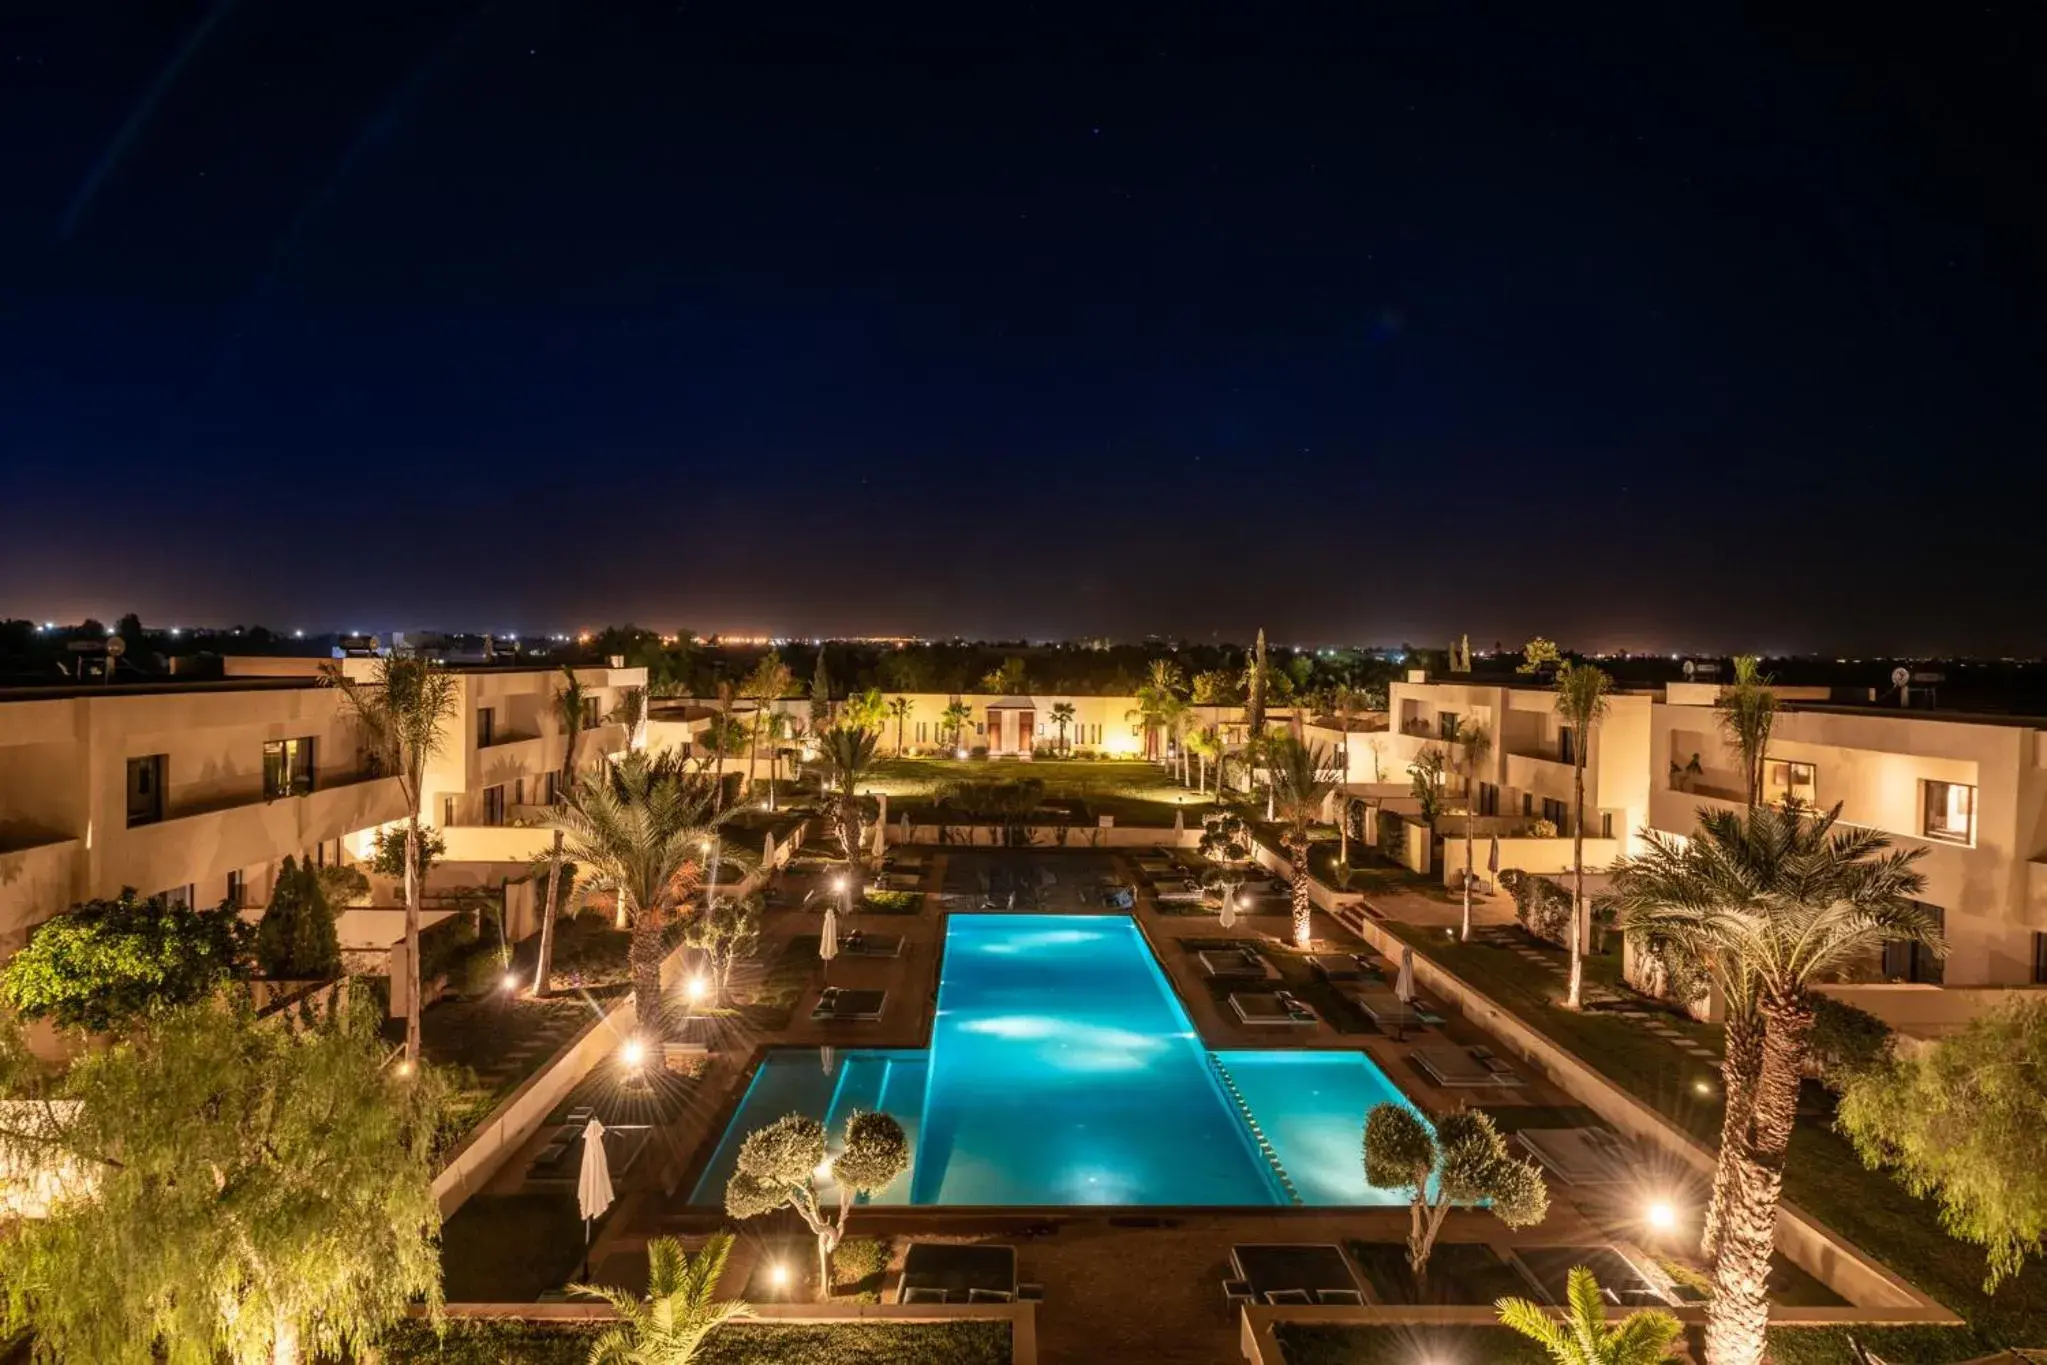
<box><xmin>478</xmin><ymin>847</ymin><xmax>1662</xmax><ymax>1365</ymax></box>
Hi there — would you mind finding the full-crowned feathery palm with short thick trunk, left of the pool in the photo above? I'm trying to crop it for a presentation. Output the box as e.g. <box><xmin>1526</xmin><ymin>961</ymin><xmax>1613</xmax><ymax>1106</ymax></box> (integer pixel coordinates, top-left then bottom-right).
<box><xmin>551</xmin><ymin>749</ymin><xmax>733</xmax><ymax>1044</ymax></box>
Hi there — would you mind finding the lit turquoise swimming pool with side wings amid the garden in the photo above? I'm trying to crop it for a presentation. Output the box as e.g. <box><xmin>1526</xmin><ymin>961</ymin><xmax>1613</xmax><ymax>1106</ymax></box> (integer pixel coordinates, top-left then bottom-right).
<box><xmin>692</xmin><ymin>915</ymin><xmax>1406</xmax><ymax>1205</ymax></box>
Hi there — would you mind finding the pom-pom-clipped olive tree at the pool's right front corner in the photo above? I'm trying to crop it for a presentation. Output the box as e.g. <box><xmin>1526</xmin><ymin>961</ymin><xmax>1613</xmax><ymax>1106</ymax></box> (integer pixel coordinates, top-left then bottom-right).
<box><xmin>1365</xmin><ymin>1103</ymin><xmax>1550</xmax><ymax>1283</ymax></box>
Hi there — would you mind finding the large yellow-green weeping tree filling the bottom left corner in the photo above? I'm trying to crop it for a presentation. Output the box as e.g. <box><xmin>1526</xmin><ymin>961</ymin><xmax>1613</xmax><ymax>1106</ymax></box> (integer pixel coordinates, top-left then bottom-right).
<box><xmin>0</xmin><ymin>1001</ymin><xmax>446</xmax><ymax>1365</ymax></box>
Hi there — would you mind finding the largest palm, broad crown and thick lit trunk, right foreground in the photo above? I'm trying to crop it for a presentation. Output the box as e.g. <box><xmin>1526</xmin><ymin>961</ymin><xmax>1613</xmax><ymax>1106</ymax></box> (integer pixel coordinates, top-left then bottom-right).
<box><xmin>1611</xmin><ymin>806</ymin><xmax>1945</xmax><ymax>1365</ymax></box>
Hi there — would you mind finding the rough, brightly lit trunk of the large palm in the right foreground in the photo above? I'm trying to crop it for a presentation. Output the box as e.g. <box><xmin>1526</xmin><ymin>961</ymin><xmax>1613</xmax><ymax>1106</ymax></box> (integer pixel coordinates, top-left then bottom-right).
<box><xmin>1705</xmin><ymin>999</ymin><xmax>1812</xmax><ymax>1365</ymax></box>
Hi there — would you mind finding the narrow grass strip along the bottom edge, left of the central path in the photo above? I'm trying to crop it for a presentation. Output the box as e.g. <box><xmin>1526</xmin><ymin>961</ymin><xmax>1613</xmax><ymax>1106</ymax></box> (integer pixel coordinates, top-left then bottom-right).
<box><xmin>379</xmin><ymin>1318</ymin><xmax>1009</xmax><ymax>1365</ymax></box>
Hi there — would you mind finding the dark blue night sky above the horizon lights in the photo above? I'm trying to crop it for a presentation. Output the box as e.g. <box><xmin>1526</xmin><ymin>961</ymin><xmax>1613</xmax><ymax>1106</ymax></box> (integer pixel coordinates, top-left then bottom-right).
<box><xmin>0</xmin><ymin>0</ymin><xmax>2047</xmax><ymax>653</ymax></box>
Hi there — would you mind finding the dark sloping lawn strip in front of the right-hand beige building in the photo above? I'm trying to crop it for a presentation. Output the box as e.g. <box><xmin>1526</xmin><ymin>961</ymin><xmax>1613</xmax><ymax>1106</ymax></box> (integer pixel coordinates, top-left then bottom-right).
<box><xmin>1390</xmin><ymin>925</ymin><xmax>2047</xmax><ymax>1359</ymax></box>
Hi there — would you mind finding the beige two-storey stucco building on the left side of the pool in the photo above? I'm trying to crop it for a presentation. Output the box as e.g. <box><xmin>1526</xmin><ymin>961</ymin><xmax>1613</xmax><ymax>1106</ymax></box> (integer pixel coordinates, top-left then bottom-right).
<box><xmin>0</xmin><ymin>659</ymin><xmax>645</xmax><ymax>956</ymax></box>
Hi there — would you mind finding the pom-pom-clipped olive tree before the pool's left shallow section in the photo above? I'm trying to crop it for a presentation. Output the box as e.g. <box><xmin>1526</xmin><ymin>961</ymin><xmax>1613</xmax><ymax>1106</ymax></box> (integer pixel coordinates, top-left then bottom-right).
<box><xmin>725</xmin><ymin>1113</ymin><xmax>909</xmax><ymax>1302</ymax></box>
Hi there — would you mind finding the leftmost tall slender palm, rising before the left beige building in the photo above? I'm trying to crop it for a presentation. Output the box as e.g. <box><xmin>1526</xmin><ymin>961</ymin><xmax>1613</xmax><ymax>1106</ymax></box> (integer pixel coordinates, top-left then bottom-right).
<box><xmin>319</xmin><ymin>655</ymin><xmax>463</xmax><ymax>1068</ymax></box>
